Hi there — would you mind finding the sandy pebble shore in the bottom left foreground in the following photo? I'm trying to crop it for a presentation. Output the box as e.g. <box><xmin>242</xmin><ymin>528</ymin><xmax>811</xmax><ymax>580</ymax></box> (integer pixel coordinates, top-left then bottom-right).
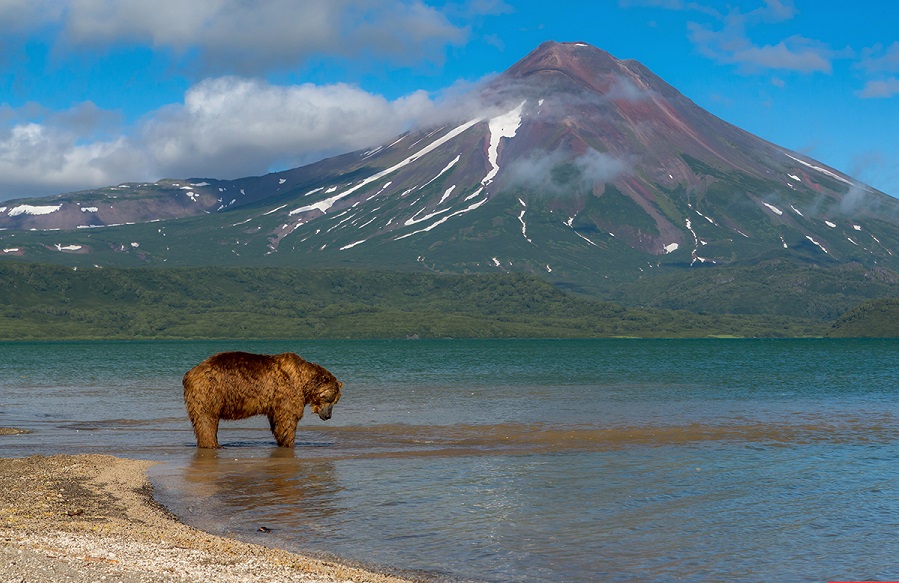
<box><xmin>0</xmin><ymin>454</ymin><xmax>422</xmax><ymax>583</ymax></box>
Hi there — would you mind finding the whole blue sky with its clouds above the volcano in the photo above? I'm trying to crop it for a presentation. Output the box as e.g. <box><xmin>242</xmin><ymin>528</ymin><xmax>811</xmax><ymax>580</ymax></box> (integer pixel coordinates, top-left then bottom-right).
<box><xmin>0</xmin><ymin>0</ymin><xmax>899</xmax><ymax>200</ymax></box>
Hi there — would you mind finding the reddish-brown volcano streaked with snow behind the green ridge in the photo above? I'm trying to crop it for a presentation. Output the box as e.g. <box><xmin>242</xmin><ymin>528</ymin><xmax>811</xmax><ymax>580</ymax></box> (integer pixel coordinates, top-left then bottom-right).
<box><xmin>0</xmin><ymin>42</ymin><xmax>899</xmax><ymax>304</ymax></box>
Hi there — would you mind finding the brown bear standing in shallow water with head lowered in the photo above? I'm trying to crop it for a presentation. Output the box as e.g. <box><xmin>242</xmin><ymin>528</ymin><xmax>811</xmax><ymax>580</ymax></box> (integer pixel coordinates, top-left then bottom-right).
<box><xmin>182</xmin><ymin>352</ymin><xmax>343</xmax><ymax>448</ymax></box>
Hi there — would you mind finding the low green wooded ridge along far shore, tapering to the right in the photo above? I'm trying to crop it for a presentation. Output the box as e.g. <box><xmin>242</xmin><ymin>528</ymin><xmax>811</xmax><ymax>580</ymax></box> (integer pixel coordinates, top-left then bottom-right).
<box><xmin>0</xmin><ymin>262</ymin><xmax>830</xmax><ymax>340</ymax></box>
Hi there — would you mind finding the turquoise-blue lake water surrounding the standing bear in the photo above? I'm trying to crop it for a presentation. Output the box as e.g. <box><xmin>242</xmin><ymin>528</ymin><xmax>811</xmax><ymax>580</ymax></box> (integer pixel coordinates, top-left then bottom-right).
<box><xmin>0</xmin><ymin>340</ymin><xmax>899</xmax><ymax>582</ymax></box>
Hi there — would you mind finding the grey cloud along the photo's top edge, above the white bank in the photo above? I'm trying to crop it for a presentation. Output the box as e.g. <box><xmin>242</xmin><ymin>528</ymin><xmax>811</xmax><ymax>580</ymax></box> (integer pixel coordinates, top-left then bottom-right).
<box><xmin>0</xmin><ymin>0</ymin><xmax>468</xmax><ymax>75</ymax></box>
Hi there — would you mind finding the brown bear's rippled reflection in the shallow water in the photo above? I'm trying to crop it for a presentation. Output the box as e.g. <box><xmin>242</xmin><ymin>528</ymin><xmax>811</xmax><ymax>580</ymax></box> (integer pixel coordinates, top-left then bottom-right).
<box><xmin>181</xmin><ymin>448</ymin><xmax>342</xmax><ymax>534</ymax></box>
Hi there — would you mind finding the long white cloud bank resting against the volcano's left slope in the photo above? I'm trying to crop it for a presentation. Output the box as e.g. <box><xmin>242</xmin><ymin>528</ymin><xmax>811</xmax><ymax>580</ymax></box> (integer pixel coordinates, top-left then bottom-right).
<box><xmin>0</xmin><ymin>77</ymin><xmax>437</xmax><ymax>200</ymax></box>
